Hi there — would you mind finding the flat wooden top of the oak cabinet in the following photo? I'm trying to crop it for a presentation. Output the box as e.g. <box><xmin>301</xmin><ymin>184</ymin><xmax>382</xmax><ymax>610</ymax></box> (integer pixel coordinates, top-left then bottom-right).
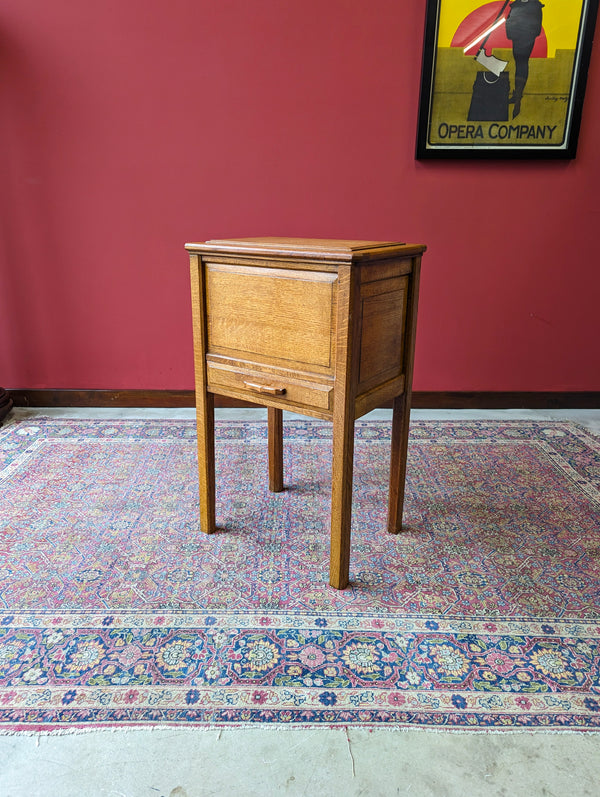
<box><xmin>185</xmin><ymin>238</ymin><xmax>425</xmax><ymax>262</ymax></box>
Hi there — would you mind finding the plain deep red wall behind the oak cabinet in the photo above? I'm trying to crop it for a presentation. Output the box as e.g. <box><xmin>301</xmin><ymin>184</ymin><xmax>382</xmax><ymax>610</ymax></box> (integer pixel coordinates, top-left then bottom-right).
<box><xmin>0</xmin><ymin>0</ymin><xmax>600</xmax><ymax>391</ymax></box>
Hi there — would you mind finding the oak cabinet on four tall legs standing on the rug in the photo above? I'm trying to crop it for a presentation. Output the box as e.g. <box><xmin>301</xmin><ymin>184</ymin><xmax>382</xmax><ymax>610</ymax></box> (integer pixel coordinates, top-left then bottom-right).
<box><xmin>186</xmin><ymin>238</ymin><xmax>425</xmax><ymax>589</ymax></box>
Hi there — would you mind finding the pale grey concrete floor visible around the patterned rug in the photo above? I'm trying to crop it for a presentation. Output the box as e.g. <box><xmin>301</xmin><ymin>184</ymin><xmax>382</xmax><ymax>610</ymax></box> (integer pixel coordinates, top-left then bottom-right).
<box><xmin>0</xmin><ymin>409</ymin><xmax>600</xmax><ymax>797</ymax></box>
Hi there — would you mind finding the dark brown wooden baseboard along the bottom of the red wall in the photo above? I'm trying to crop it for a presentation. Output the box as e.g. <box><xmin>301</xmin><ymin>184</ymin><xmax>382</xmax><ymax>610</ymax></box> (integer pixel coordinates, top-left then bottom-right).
<box><xmin>7</xmin><ymin>390</ymin><xmax>600</xmax><ymax>410</ymax></box>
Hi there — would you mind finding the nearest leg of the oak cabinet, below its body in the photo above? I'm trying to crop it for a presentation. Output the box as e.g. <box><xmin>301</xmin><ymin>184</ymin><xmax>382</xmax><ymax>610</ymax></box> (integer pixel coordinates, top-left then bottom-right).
<box><xmin>329</xmin><ymin>416</ymin><xmax>354</xmax><ymax>589</ymax></box>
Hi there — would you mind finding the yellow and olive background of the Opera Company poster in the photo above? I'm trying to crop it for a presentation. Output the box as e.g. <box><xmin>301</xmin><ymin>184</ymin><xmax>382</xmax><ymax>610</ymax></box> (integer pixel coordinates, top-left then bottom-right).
<box><xmin>428</xmin><ymin>0</ymin><xmax>584</xmax><ymax>147</ymax></box>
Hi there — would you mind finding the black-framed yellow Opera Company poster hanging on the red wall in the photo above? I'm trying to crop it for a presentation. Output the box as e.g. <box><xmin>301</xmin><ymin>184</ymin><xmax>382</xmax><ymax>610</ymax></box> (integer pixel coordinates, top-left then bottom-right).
<box><xmin>417</xmin><ymin>0</ymin><xmax>598</xmax><ymax>158</ymax></box>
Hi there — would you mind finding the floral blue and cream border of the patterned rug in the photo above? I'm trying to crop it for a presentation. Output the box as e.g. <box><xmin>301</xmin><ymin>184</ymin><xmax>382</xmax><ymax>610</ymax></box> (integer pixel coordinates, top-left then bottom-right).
<box><xmin>0</xmin><ymin>418</ymin><xmax>600</xmax><ymax>733</ymax></box>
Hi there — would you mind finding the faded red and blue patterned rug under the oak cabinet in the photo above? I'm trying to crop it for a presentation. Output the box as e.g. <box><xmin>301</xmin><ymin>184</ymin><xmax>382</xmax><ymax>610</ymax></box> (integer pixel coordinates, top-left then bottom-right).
<box><xmin>0</xmin><ymin>419</ymin><xmax>600</xmax><ymax>732</ymax></box>
